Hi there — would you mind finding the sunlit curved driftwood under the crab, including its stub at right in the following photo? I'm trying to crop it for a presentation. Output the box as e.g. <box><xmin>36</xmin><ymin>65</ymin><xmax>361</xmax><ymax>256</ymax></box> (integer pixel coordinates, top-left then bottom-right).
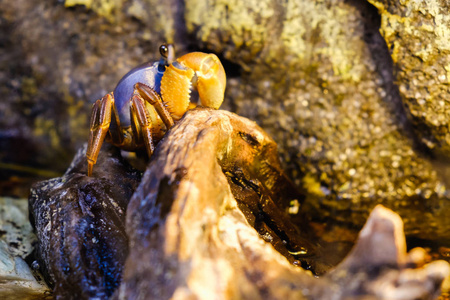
<box><xmin>115</xmin><ymin>110</ymin><xmax>448</xmax><ymax>299</ymax></box>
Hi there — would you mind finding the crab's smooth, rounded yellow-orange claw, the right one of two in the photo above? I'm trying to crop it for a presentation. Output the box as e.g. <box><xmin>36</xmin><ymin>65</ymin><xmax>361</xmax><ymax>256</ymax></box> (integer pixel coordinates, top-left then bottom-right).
<box><xmin>177</xmin><ymin>52</ymin><xmax>227</xmax><ymax>109</ymax></box>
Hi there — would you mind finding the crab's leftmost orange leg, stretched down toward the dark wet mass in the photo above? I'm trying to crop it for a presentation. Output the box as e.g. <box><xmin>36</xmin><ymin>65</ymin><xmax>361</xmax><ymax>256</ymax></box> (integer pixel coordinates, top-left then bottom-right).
<box><xmin>86</xmin><ymin>94</ymin><xmax>114</xmax><ymax>176</ymax></box>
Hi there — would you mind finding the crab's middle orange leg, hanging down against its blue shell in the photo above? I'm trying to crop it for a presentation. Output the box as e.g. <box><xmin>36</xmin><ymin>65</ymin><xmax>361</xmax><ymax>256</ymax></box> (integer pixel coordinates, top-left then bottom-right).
<box><xmin>130</xmin><ymin>95</ymin><xmax>155</xmax><ymax>157</ymax></box>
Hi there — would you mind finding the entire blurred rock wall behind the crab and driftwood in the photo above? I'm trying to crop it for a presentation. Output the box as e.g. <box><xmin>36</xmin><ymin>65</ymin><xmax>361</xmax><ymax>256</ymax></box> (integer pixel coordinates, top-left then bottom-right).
<box><xmin>0</xmin><ymin>0</ymin><xmax>450</xmax><ymax>268</ymax></box>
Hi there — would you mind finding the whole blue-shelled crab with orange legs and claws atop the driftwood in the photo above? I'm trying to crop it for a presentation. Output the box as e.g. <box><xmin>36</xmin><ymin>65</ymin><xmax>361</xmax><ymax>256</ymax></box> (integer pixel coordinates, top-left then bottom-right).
<box><xmin>86</xmin><ymin>45</ymin><xmax>226</xmax><ymax>176</ymax></box>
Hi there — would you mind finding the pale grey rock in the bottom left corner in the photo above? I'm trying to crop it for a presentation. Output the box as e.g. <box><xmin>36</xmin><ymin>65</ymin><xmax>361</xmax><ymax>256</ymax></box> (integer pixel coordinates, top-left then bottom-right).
<box><xmin>0</xmin><ymin>198</ymin><xmax>50</xmax><ymax>300</ymax></box>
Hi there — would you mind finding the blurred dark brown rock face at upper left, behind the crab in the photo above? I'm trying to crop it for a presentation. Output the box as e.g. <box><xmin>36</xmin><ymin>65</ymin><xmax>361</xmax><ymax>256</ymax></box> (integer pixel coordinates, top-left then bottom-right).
<box><xmin>0</xmin><ymin>0</ymin><xmax>184</xmax><ymax>179</ymax></box>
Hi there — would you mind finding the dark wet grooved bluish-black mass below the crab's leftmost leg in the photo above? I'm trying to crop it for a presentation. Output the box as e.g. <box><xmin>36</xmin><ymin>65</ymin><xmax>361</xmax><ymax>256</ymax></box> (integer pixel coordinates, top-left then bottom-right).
<box><xmin>29</xmin><ymin>146</ymin><xmax>140</xmax><ymax>299</ymax></box>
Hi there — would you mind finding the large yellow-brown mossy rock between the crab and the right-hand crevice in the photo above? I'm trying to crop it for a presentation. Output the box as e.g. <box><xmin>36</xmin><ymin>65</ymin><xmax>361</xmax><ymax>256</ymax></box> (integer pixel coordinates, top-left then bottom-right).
<box><xmin>186</xmin><ymin>1</ymin><xmax>449</xmax><ymax>238</ymax></box>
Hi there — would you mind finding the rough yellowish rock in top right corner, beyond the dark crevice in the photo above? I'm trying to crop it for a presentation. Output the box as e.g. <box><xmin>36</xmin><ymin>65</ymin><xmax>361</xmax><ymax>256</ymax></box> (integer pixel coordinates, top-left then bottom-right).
<box><xmin>370</xmin><ymin>0</ymin><xmax>450</xmax><ymax>159</ymax></box>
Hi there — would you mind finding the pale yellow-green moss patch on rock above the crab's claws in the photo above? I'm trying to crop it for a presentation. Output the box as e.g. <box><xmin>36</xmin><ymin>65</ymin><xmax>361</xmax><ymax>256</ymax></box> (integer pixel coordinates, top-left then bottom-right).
<box><xmin>185</xmin><ymin>0</ymin><xmax>364</xmax><ymax>81</ymax></box>
